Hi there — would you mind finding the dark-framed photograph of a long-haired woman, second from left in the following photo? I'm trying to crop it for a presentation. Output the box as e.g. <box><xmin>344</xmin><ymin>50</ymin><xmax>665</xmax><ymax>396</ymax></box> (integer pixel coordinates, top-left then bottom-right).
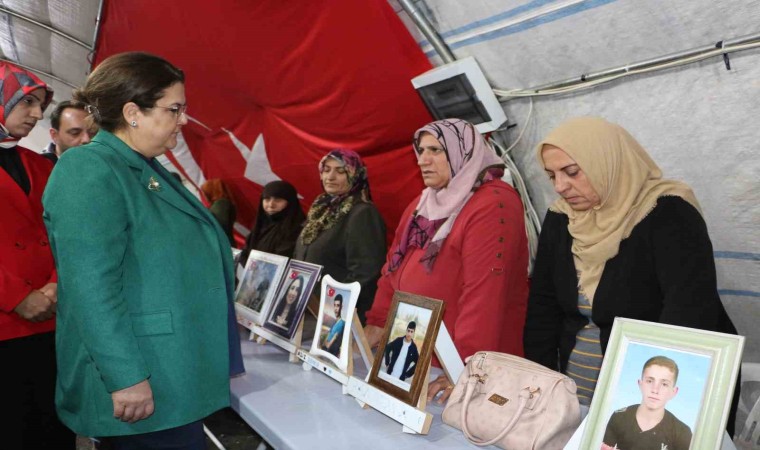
<box><xmin>264</xmin><ymin>259</ymin><xmax>322</xmax><ymax>340</ymax></box>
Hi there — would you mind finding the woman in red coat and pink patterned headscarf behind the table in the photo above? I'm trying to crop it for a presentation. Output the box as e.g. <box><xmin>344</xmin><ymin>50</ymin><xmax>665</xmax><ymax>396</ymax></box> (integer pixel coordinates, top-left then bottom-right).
<box><xmin>365</xmin><ymin>119</ymin><xmax>528</xmax><ymax>402</ymax></box>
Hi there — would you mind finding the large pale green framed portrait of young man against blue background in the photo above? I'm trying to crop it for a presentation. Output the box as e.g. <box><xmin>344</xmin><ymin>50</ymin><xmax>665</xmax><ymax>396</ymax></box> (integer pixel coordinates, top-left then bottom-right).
<box><xmin>580</xmin><ymin>318</ymin><xmax>744</xmax><ymax>450</ymax></box>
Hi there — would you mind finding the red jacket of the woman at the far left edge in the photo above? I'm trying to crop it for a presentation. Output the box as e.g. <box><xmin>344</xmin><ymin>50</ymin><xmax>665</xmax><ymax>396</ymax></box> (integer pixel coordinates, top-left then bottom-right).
<box><xmin>0</xmin><ymin>147</ymin><xmax>56</xmax><ymax>341</ymax></box>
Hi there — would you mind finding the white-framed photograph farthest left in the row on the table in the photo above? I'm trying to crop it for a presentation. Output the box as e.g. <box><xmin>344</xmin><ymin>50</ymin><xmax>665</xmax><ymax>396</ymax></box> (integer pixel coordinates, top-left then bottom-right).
<box><xmin>235</xmin><ymin>250</ymin><xmax>288</xmax><ymax>328</ymax></box>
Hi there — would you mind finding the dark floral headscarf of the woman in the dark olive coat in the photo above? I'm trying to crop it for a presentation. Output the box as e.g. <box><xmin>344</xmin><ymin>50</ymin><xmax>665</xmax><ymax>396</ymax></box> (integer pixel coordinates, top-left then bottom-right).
<box><xmin>301</xmin><ymin>149</ymin><xmax>372</xmax><ymax>245</ymax></box>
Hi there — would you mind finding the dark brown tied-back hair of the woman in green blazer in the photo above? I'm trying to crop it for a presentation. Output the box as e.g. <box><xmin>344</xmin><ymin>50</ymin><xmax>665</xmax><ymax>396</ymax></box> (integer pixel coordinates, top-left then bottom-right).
<box><xmin>74</xmin><ymin>52</ymin><xmax>185</xmax><ymax>132</ymax></box>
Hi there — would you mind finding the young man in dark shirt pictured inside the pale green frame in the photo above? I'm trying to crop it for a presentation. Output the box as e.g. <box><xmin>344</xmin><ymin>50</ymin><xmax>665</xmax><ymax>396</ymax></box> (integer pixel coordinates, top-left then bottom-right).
<box><xmin>602</xmin><ymin>355</ymin><xmax>691</xmax><ymax>450</ymax></box>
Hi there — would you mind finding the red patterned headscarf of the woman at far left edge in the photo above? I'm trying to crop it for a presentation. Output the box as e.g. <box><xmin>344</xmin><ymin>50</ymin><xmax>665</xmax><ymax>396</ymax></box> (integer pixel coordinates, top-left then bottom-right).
<box><xmin>0</xmin><ymin>61</ymin><xmax>53</xmax><ymax>141</ymax></box>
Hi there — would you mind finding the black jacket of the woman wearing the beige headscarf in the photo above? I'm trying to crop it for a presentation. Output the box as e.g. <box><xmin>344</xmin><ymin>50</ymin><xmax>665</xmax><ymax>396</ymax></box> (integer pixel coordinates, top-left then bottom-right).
<box><xmin>524</xmin><ymin>197</ymin><xmax>736</xmax><ymax>372</ymax></box>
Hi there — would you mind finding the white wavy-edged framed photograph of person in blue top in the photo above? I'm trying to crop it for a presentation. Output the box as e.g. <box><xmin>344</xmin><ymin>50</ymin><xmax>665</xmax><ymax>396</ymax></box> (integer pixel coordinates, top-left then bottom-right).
<box><xmin>309</xmin><ymin>275</ymin><xmax>361</xmax><ymax>373</ymax></box>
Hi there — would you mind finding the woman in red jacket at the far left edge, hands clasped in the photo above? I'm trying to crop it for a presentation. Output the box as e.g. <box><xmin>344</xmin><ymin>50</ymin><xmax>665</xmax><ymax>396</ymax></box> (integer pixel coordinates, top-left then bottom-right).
<box><xmin>0</xmin><ymin>62</ymin><xmax>75</xmax><ymax>450</ymax></box>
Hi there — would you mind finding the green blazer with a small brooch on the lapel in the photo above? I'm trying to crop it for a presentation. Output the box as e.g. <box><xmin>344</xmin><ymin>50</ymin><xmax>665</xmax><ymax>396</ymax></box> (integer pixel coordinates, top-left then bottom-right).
<box><xmin>42</xmin><ymin>130</ymin><xmax>234</xmax><ymax>436</ymax></box>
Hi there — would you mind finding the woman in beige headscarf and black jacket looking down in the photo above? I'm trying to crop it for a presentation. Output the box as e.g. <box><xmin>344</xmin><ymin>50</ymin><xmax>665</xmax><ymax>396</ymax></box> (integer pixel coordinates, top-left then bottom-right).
<box><xmin>524</xmin><ymin>117</ymin><xmax>738</xmax><ymax>431</ymax></box>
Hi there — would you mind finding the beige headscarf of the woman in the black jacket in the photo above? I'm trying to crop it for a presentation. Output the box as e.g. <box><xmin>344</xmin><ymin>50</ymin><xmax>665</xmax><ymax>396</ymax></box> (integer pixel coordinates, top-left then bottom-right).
<box><xmin>536</xmin><ymin>117</ymin><xmax>701</xmax><ymax>302</ymax></box>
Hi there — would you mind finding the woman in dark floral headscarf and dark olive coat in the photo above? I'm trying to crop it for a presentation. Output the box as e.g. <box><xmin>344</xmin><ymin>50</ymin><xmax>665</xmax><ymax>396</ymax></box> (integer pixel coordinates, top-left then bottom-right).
<box><xmin>293</xmin><ymin>150</ymin><xmax>385</xmax><ymax>324</ymax></box>
